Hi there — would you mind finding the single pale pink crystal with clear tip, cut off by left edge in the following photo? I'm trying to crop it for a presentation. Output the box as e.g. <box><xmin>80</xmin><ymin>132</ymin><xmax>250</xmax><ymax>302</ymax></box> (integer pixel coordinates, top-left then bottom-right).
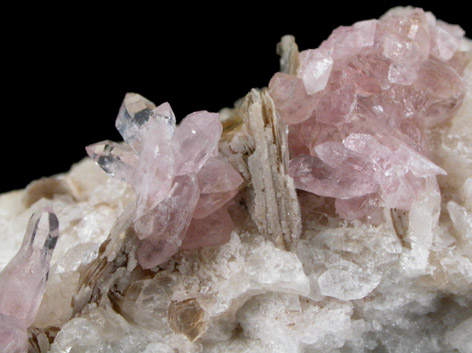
<box><xmin>0</xmin><ymin>211</ymin><xmax>59</xmax><ymax>353</ymax></box>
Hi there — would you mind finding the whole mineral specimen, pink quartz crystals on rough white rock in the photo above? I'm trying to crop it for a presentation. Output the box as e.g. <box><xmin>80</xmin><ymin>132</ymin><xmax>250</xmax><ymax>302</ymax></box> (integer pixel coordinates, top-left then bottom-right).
<box><xmin>0</xmin><ymin>8</ymin><xmax>472</xmax><ymax>353</ymax></box>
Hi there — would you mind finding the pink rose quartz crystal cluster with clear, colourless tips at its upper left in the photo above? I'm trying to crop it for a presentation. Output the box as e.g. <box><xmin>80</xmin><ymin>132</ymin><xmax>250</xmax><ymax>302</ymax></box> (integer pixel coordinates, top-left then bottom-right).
<box><xmin>86</xmin><ymin>93</ymin><xmax>243</xmax><ymax>268</ymax></box>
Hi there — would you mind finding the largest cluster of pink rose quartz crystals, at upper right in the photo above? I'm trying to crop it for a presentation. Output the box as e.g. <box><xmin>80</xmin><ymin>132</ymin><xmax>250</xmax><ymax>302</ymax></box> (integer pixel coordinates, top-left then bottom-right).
<box><xmin>269</xmin><ymin>8</ymin><xmax>464</xmax><ymax>223</ymax></box>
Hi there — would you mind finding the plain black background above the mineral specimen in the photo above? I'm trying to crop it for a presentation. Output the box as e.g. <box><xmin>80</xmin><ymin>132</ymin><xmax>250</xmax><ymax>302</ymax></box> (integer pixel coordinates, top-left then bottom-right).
<box><xmin>0</xmin><ymin>1</ymin><xmax>472</xmax><ymax>192</ymax></box>
